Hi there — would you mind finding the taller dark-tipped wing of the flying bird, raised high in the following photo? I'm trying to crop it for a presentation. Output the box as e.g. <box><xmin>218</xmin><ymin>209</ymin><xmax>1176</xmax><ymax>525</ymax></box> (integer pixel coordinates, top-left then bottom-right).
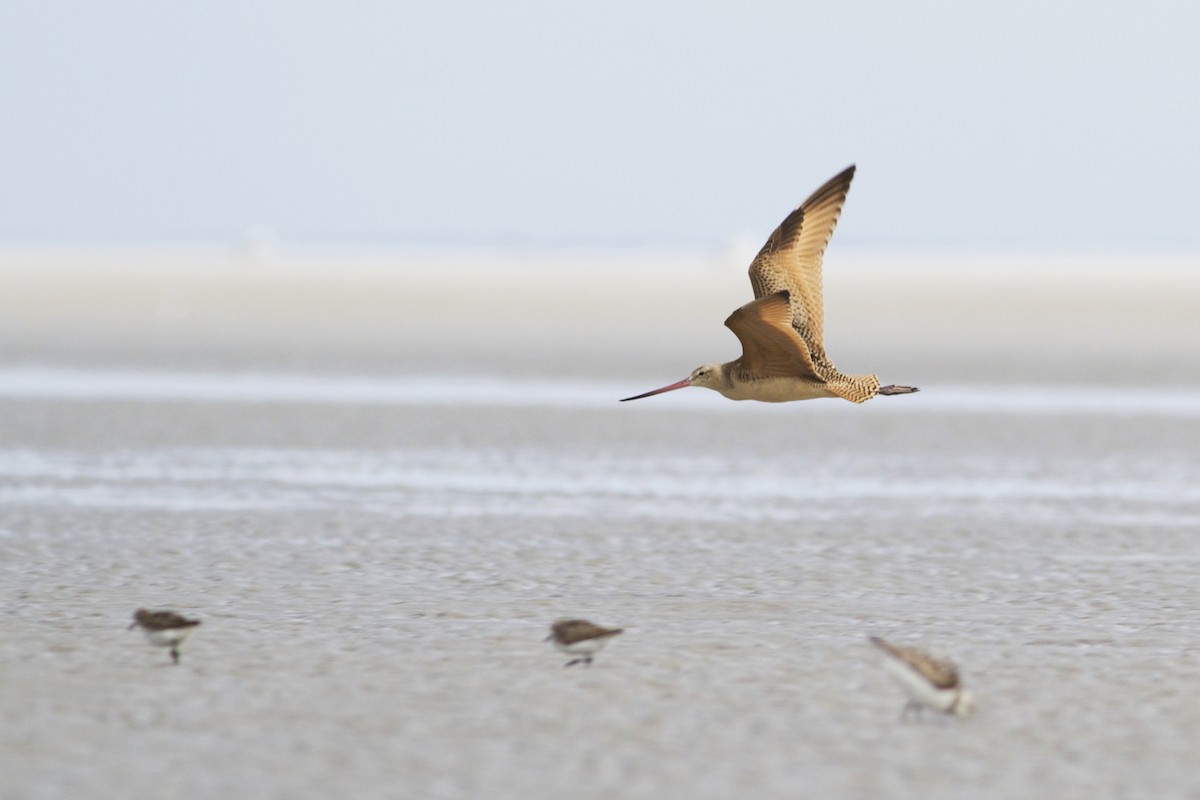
<box><xmin>750</xmin><ymin>164</ymin><xmax>854</xmax><ymax>363</ymax></box>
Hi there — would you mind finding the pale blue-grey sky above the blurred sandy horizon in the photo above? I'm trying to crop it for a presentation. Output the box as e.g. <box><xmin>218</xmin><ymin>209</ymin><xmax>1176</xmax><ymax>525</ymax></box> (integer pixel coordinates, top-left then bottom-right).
<box><xmin>0</xmin><ymin>0</ymin><xmax>1200</xmax><ymax>251</ymax></box>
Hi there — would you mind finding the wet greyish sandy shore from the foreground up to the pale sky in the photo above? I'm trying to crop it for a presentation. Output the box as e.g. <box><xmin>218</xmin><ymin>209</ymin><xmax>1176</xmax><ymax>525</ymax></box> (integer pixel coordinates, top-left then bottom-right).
<box><xmin>0</xmin><ymin>253</ymin><xmax>1200</xmax><ymax>800</ymax></box>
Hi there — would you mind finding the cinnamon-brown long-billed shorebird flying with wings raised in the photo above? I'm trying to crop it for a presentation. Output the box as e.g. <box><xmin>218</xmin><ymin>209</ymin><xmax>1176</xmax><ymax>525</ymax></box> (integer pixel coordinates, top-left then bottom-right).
<box><xmin>622</xmin><ymin>166</ymin><xmax>917</xmax><ymax>403</ymax></box>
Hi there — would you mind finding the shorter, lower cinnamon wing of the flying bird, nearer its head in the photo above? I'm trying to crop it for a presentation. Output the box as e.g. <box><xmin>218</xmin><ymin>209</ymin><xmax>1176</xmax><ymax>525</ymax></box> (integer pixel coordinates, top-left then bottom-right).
<box><xmin>725</xmin><ymin>290</ymin><xmax>820</xmax><ymax>380</ymax></box>
